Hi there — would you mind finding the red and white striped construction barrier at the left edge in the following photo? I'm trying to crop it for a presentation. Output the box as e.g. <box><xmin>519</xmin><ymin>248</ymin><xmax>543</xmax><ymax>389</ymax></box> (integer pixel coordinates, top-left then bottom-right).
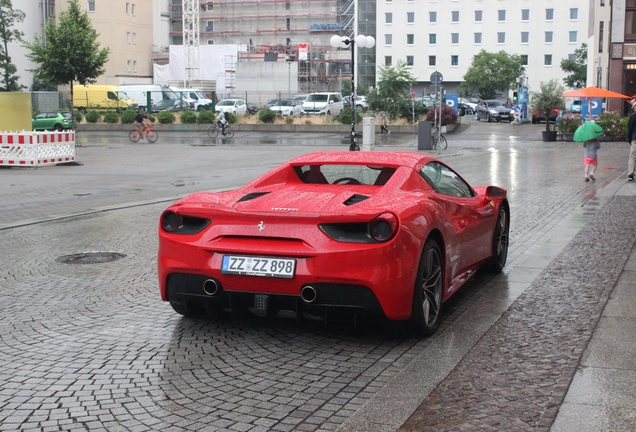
<box><xmin>0</xmin><ymin>131</ymin><xmax>75</xmax><ymax>167</ymax></box>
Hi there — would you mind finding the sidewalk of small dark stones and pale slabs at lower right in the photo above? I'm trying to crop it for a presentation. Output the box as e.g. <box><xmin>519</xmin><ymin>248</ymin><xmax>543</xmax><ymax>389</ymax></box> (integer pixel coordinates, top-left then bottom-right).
<box><xmin>399</xmin><ymin>177</ymin><xmax>636</xmax><ymax>432</ymax></box>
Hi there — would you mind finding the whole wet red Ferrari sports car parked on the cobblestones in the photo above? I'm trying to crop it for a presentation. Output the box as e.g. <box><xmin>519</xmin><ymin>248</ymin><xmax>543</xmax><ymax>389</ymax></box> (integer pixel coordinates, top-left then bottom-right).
<box><xmin>158</xmin><ymin>151</ymin><xmax>510</xmax><ymax>335</ymax></box>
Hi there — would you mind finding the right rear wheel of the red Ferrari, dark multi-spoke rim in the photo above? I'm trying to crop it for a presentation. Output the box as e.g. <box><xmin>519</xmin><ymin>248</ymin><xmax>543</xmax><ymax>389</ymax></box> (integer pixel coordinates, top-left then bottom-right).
<box><xmin>411</xmin><ymin>238</ymin><xmax>444</xmax><ymax>336</ymax></box>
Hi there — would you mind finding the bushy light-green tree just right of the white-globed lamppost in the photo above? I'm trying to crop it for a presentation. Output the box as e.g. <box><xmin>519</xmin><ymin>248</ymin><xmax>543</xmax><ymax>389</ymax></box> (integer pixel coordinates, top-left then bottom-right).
<box><xmin>367</xmin><ymin>61</ymin><xmax>417</xmax><ymax>119</ymax></box>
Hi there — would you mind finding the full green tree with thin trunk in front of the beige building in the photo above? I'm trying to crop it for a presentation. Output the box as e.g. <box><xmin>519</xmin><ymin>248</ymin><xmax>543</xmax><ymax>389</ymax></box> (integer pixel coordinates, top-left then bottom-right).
<box><xmin>23</xmin><ymin>0</ymin><xmax>110</xmax><ymax>125</ymax></box>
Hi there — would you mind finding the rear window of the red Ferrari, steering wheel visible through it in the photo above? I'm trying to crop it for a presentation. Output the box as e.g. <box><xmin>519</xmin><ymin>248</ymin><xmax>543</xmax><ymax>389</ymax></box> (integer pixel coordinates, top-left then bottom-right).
<box><xmin>294</xmin><ymin>164</ymin><xmax>396</xmax><ymax>186</ymax></box>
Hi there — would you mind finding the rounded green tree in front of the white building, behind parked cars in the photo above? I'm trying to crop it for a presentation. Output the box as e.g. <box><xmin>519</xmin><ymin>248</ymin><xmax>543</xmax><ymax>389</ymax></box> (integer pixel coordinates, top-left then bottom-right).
<box><xmin>459</xmin><ymin>50</ymin><xmax>523</xmax><ymax>99</ymax></box>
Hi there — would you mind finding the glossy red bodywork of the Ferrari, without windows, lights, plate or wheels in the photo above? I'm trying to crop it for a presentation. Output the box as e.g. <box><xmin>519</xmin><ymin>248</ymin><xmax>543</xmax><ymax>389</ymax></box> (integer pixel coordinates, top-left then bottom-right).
<box><xmin>158</xmin><ymin>151</ymin><xmax>506</xmax><ymax>320</ymax></box>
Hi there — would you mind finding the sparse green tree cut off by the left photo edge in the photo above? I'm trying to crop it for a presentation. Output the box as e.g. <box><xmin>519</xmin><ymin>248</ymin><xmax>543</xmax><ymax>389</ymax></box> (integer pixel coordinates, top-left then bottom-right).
<box><xmin>0</xmin><ymin>0</ymin><xmax>25</xmax><ymax>91</ymax></box>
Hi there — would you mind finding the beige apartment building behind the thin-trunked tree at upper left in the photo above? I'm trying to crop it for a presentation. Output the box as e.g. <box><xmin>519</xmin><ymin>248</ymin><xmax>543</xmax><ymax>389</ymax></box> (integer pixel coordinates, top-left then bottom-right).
<box><xmin>56</xmin><ymin>0</ymin><xmax>155</xmax><ymax>85</ymax></box>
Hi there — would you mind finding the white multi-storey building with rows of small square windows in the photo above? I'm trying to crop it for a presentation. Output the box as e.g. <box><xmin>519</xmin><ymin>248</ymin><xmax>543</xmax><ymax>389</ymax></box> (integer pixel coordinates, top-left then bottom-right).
<box><xmin>376</xmin><ymin>0</ymin><xmax>590</xmax><ymax>96</ymax></box>
